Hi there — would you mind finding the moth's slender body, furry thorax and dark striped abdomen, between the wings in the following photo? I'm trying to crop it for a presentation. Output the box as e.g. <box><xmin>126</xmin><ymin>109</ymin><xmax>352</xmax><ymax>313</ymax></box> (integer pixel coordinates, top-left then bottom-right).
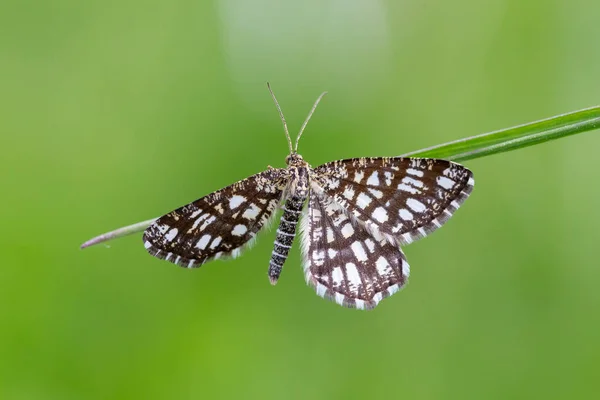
<box><xmin>269</xmin><ymin>168</ymin><xmax>308</xmax><ymax>285</ymax></box>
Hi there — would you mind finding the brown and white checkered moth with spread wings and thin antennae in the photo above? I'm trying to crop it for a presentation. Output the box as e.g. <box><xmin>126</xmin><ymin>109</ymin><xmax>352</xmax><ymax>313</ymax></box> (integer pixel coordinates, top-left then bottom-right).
<box><xmin>143</xmin><ymin>84</ymin><xmax>475</xmax><ymax>309</ymax></box>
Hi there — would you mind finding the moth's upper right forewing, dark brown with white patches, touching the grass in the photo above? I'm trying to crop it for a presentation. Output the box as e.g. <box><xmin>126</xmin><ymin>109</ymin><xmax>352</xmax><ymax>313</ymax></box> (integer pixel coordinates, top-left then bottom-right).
<box><xmin>312</xmin><ymin>157</ymin><xmax>475</xmax><ymax>244</ymax></box>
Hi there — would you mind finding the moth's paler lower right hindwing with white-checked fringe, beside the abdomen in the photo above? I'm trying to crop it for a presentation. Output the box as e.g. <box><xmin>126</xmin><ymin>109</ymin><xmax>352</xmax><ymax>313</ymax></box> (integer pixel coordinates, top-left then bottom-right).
<box><xmin>302</xmin><ymin>188</ymin><xmax>409</xmax><ymax>309</ymax></box>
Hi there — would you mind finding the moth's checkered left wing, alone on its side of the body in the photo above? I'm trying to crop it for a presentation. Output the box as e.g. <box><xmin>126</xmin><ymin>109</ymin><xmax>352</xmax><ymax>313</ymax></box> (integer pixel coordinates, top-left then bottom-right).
<box><xmin>144</xmin><ymin>168</ymin><xmax>286</xmax><ymax>268</ymax></box>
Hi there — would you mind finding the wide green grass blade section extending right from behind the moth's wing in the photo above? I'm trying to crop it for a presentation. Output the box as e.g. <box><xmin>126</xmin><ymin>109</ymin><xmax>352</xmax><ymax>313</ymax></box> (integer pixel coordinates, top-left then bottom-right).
<box><xmin>402</xmin><ymin>106</ymin><xmax>600</xmax><ymax>161</ymax></box>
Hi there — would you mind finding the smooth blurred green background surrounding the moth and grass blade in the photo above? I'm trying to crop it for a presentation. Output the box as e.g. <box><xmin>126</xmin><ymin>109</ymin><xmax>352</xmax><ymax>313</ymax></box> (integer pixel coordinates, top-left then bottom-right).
<box><xmin>0</xmin><ymin>0</ymin><xmax>600</xmax><ymax>399</ymax></box>
